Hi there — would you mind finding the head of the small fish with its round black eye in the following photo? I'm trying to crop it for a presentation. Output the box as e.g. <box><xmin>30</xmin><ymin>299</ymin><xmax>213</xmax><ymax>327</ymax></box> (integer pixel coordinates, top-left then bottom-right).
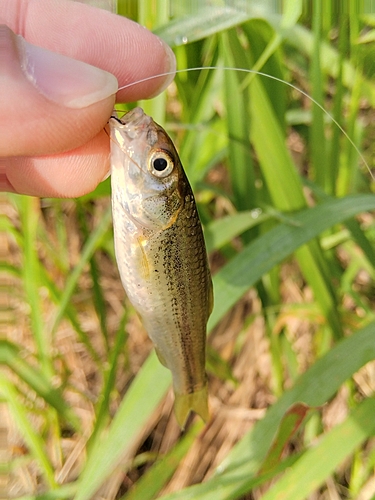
<box><xmin>109</xmin><ymin>107</ymin><xmax>186</xmax><ymax>229</ymax></box>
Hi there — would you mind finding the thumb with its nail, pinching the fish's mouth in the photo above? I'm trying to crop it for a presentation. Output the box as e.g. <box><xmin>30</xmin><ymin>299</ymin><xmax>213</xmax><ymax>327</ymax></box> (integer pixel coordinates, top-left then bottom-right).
<box><xmin>0</xmin><ymin>25</ymin><xmax>117</xmax><ymax>157</ymax></box>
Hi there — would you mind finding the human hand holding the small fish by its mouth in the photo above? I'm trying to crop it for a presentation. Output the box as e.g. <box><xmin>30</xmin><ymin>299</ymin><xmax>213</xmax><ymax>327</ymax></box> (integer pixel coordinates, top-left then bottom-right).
<box><xmin>0</xmin><ymin>0</ymin><xmax>175</xmax><ymax>197</ymax></box>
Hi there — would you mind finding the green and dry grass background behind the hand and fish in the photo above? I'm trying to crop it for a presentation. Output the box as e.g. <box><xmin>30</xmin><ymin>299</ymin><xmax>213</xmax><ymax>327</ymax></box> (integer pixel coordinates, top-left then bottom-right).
<box><xmin>0</xmin><ymin>0</ymin><xmax>375</xmax><ymax>500</ymax></box>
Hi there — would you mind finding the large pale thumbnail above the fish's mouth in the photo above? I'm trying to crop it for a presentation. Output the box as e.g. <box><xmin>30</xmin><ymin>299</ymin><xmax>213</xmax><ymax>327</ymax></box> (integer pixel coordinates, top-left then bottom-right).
<box><xmin>17</xmin><ymin>36</ymin><xmax>118</xmax><ymax>109</ymax></box>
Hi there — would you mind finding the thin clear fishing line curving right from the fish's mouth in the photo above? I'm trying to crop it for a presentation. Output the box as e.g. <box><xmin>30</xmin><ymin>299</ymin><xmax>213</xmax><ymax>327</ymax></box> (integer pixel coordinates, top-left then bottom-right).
<box><xmin>118</xmin><ymin>66</ymin><xmax>375</xmax><ymax>181</ymax></box>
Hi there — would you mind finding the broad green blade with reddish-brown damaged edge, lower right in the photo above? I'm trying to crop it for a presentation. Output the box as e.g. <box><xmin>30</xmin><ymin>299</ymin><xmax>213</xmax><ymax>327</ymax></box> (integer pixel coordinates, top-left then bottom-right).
<box><xmin>157</xmin><ymin>323</ymin><xmax>375</xmax><ymax>500</ymax></box>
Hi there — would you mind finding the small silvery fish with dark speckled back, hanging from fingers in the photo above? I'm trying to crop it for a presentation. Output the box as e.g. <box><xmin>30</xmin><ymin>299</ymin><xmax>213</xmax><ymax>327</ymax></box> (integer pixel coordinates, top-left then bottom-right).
<box><xmin>109</xmin><ymin>107</ymin><xmax>213</xmax><ymax>429</ymax></box>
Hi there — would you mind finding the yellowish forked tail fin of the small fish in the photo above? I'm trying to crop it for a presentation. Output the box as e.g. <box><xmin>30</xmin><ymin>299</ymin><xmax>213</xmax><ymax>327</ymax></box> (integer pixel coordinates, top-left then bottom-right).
<box><xmin>174</xmin><ymin>384</ymin><xmax>210</xmax><ymax>430</ymax></box>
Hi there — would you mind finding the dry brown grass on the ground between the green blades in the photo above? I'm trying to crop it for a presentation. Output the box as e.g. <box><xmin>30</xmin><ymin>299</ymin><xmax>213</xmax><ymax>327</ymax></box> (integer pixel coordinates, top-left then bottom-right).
<box><xmin>1</xmin><ymin>194</ymin><xmax>364</xmax><ymax>500</ymax></box>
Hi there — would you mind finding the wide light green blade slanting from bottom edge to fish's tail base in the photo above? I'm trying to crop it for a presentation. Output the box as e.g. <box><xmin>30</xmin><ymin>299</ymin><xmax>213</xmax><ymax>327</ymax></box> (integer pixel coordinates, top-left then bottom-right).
<box><xmin>75</xmin><ymin>353</ymin><xmax>171</xmax><ymax>500</ymax></box>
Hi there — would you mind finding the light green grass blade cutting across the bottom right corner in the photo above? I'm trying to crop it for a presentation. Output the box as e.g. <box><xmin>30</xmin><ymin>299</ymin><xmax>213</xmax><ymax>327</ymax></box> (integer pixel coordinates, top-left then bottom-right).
<box><xmin>263</xmin><ymin>398</ymin><xmax>375</xmax><ymax>500</ymax></box>
